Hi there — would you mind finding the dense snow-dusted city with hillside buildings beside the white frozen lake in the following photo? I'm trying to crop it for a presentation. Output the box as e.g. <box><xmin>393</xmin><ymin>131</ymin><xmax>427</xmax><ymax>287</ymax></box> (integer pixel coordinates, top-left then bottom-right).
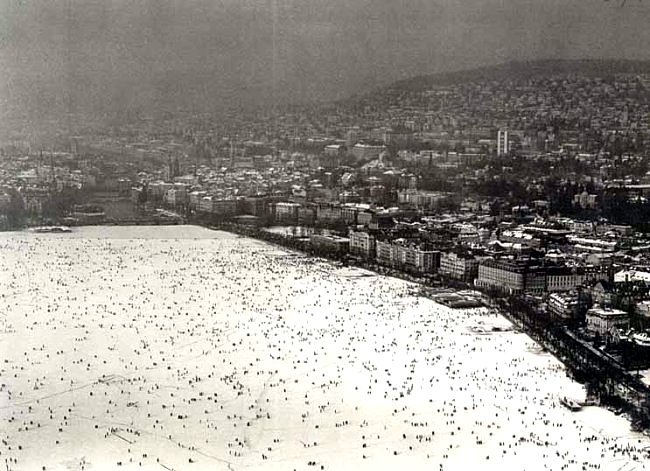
<box><xmin>0</xmin><ymin>61</ymin><xmax>650</xmax><ymax>468</ymax></box>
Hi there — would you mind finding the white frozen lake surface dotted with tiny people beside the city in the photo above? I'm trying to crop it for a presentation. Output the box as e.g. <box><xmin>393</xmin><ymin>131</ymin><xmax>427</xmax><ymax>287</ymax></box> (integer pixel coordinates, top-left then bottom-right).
<box><xmin>0</xmin><ymin>226</ymin><xmax>650</xmax><ymax>471</ymax></box>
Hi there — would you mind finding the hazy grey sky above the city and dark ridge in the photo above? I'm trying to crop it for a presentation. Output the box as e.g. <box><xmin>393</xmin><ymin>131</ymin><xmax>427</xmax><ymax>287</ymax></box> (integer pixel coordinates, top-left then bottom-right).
<box><xmin>0</xmin><ymin>0</ymin><xmax>650</xmax><ymax>115</ymax></box>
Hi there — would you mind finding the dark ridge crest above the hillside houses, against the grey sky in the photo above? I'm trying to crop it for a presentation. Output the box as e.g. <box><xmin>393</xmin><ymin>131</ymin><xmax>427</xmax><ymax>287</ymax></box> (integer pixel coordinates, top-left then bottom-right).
<box><xmin>382</xmin><ymin>59</ymin><xmax>650</xmax><ymax>92</ymax></box>
